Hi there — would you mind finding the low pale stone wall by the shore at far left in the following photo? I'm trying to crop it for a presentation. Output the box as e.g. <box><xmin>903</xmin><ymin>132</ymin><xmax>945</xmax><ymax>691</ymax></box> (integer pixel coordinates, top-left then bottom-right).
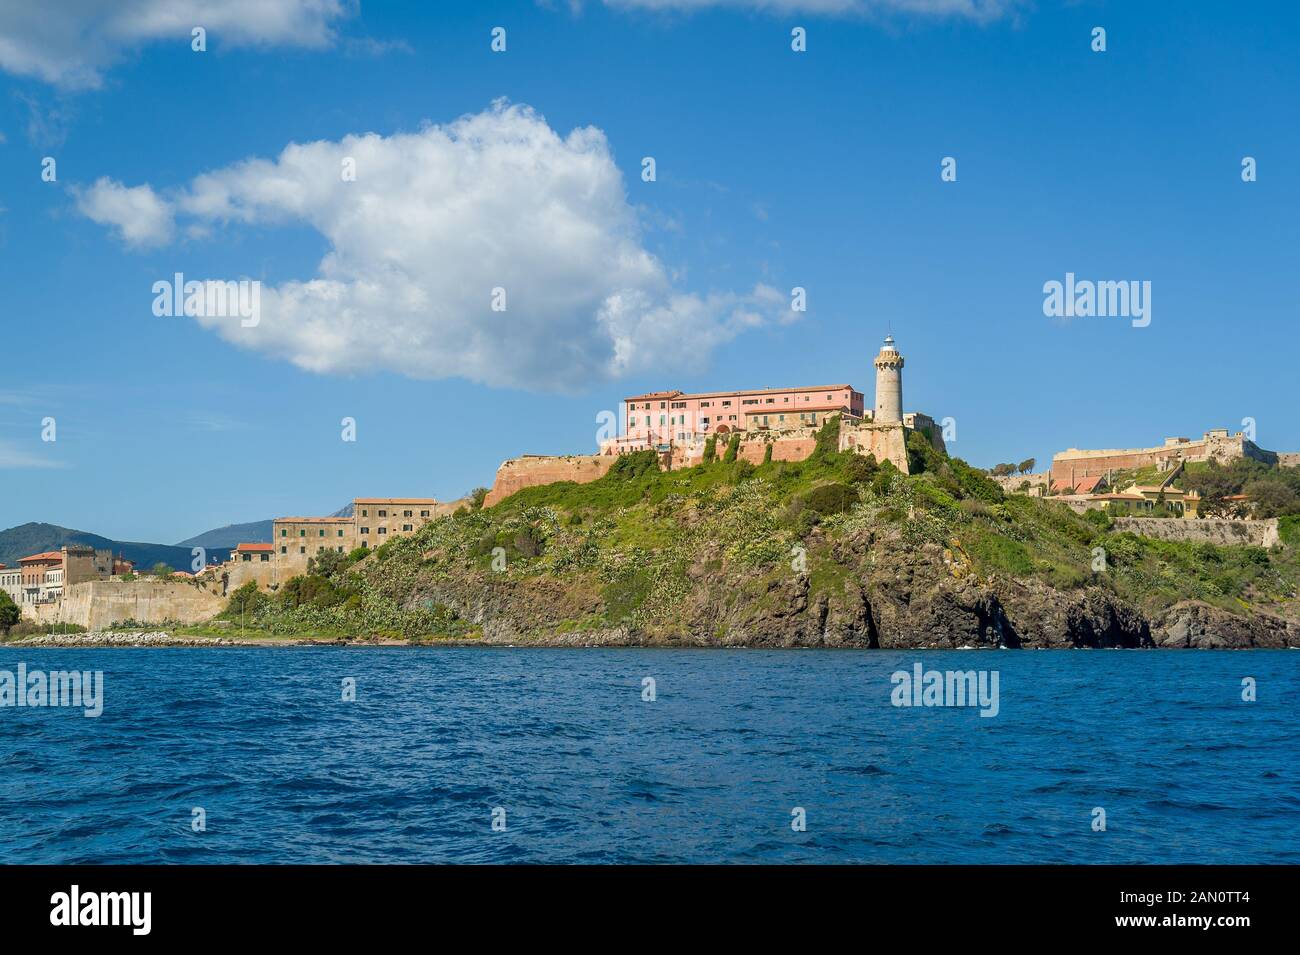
<box><xmin>31</xmin><ymin>579</ymin><xmax>226</xmax><ymax>630</ymax></box>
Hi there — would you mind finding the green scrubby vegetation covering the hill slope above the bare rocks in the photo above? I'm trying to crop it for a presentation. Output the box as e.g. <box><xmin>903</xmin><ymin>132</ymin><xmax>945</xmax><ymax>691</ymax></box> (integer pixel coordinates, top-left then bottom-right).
<box><xmin>208</xmin><ymin>418</ymin><xmax>1300</xmax><ymax>639</ymax></box>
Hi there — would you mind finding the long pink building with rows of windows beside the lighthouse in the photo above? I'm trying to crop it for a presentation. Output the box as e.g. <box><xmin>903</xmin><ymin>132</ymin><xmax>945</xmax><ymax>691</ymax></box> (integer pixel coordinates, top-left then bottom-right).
<box><xmin>615</xmin><ymin>385</ymin><xmax>865</xmax><ymax>451</ymax></box>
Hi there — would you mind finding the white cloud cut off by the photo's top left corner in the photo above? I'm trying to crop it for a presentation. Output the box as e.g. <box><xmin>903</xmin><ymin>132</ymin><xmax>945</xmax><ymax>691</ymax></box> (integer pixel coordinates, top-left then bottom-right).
<box><xmin>0</xmin><ymin>0</ymin><xmax>345</xmax><ymax>88</ymax></box>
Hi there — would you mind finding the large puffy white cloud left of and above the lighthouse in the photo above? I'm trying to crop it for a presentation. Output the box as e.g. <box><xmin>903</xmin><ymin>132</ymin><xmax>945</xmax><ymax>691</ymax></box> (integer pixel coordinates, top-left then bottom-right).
<box><xmin>82</xmin><ymin>103</ymin><xmax>789</xmax><ymax>391</ymax></box>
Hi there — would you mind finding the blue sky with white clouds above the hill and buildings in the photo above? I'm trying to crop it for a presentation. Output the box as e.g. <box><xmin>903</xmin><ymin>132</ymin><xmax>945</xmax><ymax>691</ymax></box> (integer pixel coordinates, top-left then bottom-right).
<box><xmin>0</xmin><ymin>0</ymin><xmax>1300</xmax><ymax>542</ymax></box>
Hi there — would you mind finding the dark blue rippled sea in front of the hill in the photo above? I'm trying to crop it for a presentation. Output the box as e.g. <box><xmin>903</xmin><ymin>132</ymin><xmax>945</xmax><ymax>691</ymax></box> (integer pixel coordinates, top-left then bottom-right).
<box><xmin>0</xmin><ymin>647</ymin><xmax>1300</xmax><ymax>864</ymax></box>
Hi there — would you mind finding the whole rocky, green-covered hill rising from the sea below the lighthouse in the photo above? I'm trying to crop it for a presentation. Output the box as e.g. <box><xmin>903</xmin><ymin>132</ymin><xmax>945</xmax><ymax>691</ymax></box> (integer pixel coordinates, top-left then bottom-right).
<box><xmin>213</xmin><ymin>421</ymin><xmax>1300</xmax><ymax>647</ymax></box>
